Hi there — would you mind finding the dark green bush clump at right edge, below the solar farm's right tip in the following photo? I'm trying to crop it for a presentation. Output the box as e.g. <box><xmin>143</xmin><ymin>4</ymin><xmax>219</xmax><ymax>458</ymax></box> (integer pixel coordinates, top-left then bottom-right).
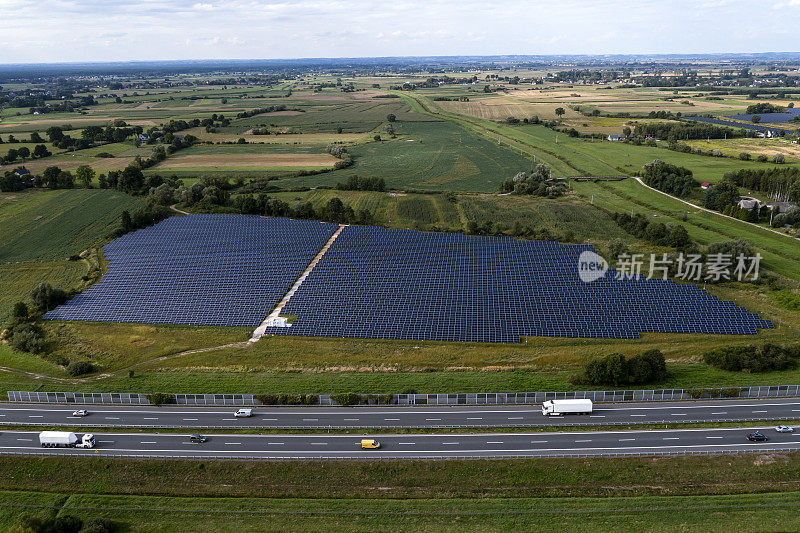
<box><xmin>703</xmin><ymin>343</ymin><xmax>800</xmax><ymax>373</ymax></box>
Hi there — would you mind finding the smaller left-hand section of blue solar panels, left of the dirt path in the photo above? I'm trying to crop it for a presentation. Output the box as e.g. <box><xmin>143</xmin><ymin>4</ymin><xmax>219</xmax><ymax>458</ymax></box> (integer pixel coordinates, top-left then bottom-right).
<box><xmin>45</xmin><ymin>215</ymin><xmax>337</xmax><ymax>327</ymax></box>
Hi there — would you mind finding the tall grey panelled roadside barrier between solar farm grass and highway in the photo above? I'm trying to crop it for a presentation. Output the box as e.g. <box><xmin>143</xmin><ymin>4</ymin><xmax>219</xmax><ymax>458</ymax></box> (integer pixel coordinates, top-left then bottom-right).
<box><xmin>8</xmin><ymin>385</ymin><xmax>800</xmax><ymax>407</ymax></box>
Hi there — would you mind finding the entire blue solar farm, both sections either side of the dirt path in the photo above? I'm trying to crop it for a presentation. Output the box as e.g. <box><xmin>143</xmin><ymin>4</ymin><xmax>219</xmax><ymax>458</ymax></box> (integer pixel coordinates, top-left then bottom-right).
<box><xmin>45</xmin><ymin>215</ymin><xmax>773</xmax><ymax>342</ymax></box>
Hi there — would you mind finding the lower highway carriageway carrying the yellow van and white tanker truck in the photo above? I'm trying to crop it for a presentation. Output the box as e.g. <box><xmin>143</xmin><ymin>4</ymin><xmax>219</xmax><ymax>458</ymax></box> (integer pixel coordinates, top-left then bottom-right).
<box><xmin>0</xmin><ymin>427</ymin><xmax>800</xmax><ymax>459</ymax></box>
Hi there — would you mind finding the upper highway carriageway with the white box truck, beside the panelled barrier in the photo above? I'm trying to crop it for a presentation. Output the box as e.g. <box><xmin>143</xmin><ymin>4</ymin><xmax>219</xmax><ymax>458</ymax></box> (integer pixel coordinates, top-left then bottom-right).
<box><xmin>0</xmin><ymin>398</ymin><xmax>800</xmax><ymax>429</ymax></box>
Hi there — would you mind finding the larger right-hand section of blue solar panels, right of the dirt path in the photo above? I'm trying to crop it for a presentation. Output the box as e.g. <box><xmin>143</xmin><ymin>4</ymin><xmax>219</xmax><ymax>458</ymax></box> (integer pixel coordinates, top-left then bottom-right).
<box><xmin>267</xmin><ymin>226</ymin><xmax>772</xmax><ymax>342</ymax></box>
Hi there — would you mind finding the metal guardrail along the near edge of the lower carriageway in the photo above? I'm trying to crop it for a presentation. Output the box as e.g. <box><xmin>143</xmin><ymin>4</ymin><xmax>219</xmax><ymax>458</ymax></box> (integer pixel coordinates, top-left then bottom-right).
<box><xmin>0</xmin><ymin>446</ymin><xmax>800</xmax><ymax>461</ymax></box>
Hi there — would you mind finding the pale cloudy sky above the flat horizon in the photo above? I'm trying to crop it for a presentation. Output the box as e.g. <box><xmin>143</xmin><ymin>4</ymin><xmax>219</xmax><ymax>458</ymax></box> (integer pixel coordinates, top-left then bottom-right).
<box><xmin>0</xmin><ymin>0</ymin><xmax>800</xmax><ymax>63</ymax></box>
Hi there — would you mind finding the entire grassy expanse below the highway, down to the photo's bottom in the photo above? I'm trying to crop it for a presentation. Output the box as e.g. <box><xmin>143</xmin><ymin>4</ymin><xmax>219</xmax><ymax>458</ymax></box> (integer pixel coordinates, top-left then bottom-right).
<box><xmin>0</xmin><ymin>453</ymin><xmax>800</xmax><ymax>532</ymax></box>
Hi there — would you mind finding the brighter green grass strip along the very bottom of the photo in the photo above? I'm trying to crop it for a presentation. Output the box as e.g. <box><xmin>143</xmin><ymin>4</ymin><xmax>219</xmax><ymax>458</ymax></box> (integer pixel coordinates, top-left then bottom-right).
<box><xmin>0</xmin><ymin>491</ymin><xmax>800</xmax><ymax>532</ymax></box>
